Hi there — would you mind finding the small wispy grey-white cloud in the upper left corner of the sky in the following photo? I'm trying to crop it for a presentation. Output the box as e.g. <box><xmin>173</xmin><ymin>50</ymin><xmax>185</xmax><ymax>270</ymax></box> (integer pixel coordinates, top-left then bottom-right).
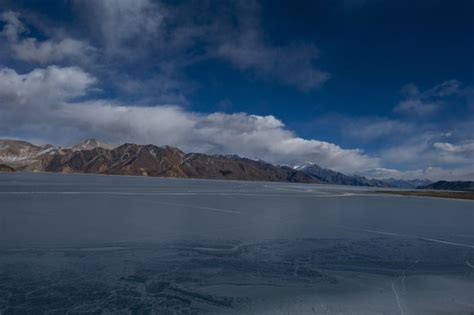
<box><xmin>0</xmin><ymin>11</ymin><xmax>94</xmax><ymax>64</ymax></box>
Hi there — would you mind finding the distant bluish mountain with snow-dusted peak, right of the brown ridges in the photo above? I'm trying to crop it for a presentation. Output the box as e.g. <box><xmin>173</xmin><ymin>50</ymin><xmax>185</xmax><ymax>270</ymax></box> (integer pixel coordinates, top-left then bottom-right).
<box><xmin>295</xmin><ymin>163</ymin><xmax>391</xmax><ymax>187</ymax></box>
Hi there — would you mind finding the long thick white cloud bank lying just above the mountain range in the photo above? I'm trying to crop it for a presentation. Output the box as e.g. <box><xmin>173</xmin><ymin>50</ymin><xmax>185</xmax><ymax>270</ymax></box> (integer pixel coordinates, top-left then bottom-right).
<box><xmin>0</xmin><ymin>66</ymin><xmax>379</xmax><ymax>173</ymax></box>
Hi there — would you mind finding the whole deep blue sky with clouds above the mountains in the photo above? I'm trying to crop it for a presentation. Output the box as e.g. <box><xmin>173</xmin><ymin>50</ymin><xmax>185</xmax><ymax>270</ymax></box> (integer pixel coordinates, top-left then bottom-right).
<box><xmin>0</xmin><ymin>0</ymin><xmax>474</xmax><ymax>180</ymax></box>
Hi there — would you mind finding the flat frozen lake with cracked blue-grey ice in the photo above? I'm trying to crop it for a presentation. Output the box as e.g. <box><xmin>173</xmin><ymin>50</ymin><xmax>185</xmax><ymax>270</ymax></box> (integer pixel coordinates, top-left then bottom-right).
<box><xmin>0</xmin><ymin>173</ymin><xmax>474</xmax><ymax>314</ymax></box>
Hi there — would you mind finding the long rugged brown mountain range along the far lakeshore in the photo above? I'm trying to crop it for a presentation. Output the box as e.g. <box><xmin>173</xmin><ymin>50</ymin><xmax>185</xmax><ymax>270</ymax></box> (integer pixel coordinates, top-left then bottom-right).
<box><xmin>0</xmin><ymin>139</ymin><xmax>431</xmax><ymax>188</ymax></box>
